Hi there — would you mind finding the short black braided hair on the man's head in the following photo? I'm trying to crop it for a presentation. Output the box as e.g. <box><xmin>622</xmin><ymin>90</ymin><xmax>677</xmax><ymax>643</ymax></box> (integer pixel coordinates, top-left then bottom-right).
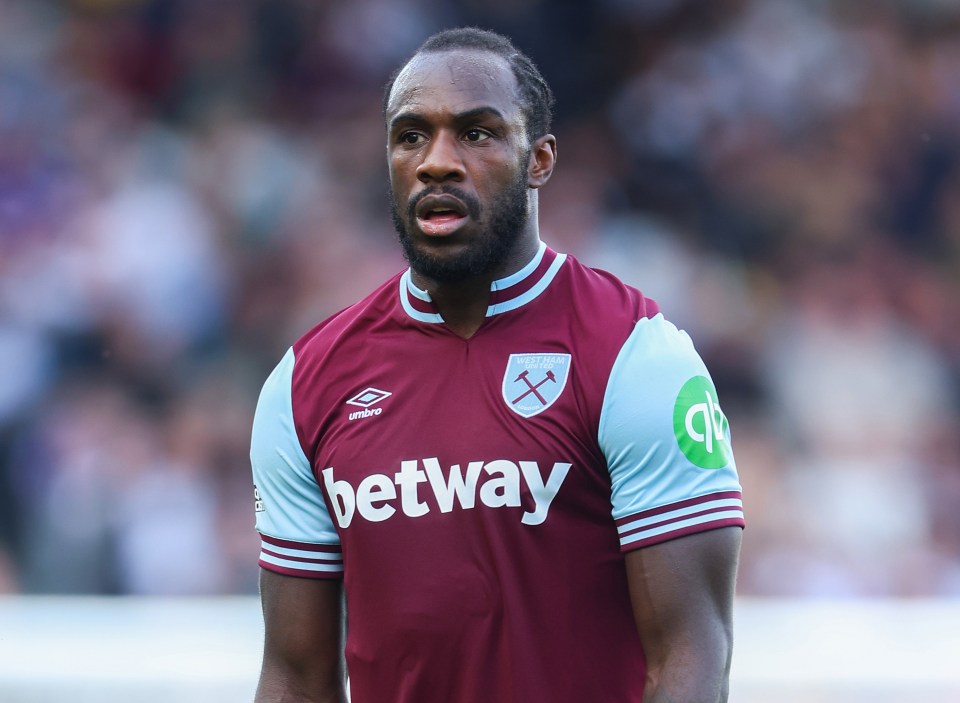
<box><xmin>383</xmin><ymin>27</ymin><xmax>554</xmax><ymax>142</ymax></box>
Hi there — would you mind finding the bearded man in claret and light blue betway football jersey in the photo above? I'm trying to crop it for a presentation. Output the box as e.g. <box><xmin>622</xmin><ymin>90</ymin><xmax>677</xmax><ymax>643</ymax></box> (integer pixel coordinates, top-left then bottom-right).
<box><xmin>251</xmin><ymin>24</ymin><xmax>743</xmax><ymax>703</ymax></box>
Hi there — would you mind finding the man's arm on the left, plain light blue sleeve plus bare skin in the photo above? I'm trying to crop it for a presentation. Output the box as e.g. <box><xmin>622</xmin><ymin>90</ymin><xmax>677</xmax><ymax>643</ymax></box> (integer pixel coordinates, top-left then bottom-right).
<box><xmin>250</xmin><ymin>350</ymin><xmax>344</xmax><ymax>703</ymax></box>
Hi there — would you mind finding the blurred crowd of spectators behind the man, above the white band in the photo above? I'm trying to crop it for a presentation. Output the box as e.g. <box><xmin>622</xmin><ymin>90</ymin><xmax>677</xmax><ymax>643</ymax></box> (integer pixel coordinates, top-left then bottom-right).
<box><xmin>0</xmin><ymin>0</ymin><xmax>960</xmax><ymax>596</ymax></box>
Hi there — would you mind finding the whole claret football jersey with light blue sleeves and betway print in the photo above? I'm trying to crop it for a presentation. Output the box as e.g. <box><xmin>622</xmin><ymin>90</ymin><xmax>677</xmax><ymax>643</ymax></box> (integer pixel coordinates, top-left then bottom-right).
<box><xmin>251</xmin><ymin>245</ymin><xmax>743</xmax><ymax>703</ymax></box>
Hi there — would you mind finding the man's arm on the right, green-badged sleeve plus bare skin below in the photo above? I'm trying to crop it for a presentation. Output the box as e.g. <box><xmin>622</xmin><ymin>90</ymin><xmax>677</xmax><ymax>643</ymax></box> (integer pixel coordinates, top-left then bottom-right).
<box><xmin>599</xmin><ymin>315</ymin><xmax>744</xmax><ymax>701</ymax></box>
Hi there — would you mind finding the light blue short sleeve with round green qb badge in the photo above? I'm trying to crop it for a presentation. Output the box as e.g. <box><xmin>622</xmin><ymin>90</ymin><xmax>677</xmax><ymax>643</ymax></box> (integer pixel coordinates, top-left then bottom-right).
<box><xmin>598</xmin><ymin>314</ymin><xmax>744</xmax><ymax>551</ymax></box>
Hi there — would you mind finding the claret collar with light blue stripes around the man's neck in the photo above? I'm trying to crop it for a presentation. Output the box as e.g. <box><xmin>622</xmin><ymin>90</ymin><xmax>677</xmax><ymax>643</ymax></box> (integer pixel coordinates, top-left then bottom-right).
<box><xmin>400</xmin><ymin>242</ymin><xmax>567</xmax><ymax>323</ymax></box>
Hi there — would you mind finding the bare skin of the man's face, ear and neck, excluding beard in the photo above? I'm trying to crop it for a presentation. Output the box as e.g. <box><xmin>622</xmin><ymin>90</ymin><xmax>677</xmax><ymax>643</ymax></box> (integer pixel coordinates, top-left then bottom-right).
<box><xmin>387</xmin><ymin>52</ymin><xmax>557</xmax><ymax>338</ymax></box>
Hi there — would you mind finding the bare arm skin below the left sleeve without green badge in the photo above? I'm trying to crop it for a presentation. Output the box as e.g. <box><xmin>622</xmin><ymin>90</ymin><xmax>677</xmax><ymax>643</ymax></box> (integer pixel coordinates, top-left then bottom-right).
<box><xmin>256</xmin><ymin>569</ymin><xmax>345</xmax><ymax>703</ymax></box>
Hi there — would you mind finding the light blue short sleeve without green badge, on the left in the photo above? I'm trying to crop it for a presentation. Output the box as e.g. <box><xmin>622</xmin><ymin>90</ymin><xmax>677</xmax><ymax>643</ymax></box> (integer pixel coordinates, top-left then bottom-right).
<box><xmin>250</xmin><ymin>349</ymin><xmax>343</xmax><ymax>578</ymax></box>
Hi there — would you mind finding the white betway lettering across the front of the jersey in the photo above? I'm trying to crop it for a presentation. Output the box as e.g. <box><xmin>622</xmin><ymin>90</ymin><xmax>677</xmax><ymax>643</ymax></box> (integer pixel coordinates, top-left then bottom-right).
<box><xmin>322</xmin><ymin>457</ymin><xmax>571</xmax><ymax>527</ymax></box>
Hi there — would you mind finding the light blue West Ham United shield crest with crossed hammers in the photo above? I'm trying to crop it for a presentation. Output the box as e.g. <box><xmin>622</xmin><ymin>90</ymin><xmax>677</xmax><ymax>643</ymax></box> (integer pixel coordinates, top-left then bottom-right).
<box><xmin>503</xmin><ymin>354</ymin><xmax>570</xmax><ymax>417</ymax></box>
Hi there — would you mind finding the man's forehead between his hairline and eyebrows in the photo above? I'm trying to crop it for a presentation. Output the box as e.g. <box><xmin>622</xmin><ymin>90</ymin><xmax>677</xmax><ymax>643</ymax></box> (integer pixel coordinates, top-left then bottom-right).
<box><xmin>387</xmin><ymin>50</ymin><xmax>521</xmax><ymax>122</ymax></box>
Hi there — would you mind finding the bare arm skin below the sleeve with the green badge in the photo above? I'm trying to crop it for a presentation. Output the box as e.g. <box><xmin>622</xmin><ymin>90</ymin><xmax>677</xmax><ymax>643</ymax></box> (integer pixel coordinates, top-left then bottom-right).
<box><xmin>625</xmin><ymin>527</ymin><xmax>741</xmax><ymax>700</ymax></box>
